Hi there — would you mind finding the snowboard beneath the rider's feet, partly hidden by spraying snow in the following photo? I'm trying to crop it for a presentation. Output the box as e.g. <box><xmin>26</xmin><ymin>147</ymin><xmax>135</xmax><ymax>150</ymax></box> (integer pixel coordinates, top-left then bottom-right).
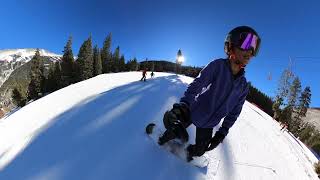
<box><xmin>146</xmin><ymin>123</ymin><xmax>209</xmax><ymax>169</ymax></box>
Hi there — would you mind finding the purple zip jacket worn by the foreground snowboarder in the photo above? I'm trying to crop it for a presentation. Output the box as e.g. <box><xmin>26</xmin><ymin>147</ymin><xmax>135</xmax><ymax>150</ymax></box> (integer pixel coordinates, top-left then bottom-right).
<box><xmin>180</xmin><ymin>59</ymin><xmax>249</xmax><ymax>135</ymax></box>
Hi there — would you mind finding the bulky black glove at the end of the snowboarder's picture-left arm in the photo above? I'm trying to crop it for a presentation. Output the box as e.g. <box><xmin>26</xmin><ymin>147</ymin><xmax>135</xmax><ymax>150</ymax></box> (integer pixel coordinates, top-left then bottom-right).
<box><xmin>163</xmin><ymin>103</ymin><xmax>191</xmax><ymax>129</ymax></box>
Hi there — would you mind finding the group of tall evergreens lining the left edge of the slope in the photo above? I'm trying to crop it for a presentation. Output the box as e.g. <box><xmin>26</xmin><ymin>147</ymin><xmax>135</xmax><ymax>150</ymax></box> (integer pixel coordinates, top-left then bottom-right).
<box><xmin>12</xmin><ymin>34</ymin><xmax>139</xmax><ymax>107</ymax></box>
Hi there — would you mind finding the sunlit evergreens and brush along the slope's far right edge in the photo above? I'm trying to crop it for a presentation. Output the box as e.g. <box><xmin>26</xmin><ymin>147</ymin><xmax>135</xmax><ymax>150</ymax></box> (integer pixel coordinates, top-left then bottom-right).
<box><xmin>272</xmin><ymin>69</ymin><xmax>320</xmax><ymax>154</ymax></box>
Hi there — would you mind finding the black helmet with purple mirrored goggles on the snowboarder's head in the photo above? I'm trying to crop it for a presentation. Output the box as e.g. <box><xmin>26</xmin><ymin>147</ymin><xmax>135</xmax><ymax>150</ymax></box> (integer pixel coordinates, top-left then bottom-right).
<box><xmin>224</xmin><ymin>26</ymin><xmax>261</xmax><ymax>56</ymax></box>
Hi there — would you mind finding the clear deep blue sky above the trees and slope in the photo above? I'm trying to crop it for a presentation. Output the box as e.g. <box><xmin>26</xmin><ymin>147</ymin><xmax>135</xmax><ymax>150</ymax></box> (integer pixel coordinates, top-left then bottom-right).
<box><xmin>0</xmin><ymin>0</ymin><xmax>320</xmax><ymax>107</ymax></box>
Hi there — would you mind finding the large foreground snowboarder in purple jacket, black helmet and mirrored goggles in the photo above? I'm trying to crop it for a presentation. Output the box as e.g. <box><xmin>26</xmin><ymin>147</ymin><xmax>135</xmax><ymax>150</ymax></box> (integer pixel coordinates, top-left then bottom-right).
<box><xmin>158</xmin><ymin>26</ymin><xmax>261</xmax><ymax>161</ymax></box>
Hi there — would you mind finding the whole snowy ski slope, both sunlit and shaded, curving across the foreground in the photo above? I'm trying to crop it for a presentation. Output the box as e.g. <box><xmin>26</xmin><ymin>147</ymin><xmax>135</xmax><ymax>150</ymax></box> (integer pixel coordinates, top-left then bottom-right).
<box><xmin>0</xmin><ymin>72</ymin><xmax>318</xmax><ymax>180</ymax></box>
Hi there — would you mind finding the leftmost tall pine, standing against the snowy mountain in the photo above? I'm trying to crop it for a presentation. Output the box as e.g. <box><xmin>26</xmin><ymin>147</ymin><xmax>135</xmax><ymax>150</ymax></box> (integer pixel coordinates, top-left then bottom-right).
<box><xmin>28</xmin><ymin>49</ymin><xmax>44</xmax><ymax>100</ymax></box>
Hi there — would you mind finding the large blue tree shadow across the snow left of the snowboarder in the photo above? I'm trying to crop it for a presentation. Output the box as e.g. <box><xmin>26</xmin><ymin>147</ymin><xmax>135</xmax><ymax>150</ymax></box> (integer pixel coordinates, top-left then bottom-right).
<box><xmin>0</xmin><ymin>75</ymin><xmax>208</xmax><ymax>180</ymax></box>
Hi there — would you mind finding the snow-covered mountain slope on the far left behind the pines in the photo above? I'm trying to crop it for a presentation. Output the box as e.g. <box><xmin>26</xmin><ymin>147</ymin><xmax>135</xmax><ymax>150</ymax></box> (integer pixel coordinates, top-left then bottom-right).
<box><xmin>0</xmin><ymin>49</ymin><xmax>61</xmax><ymax>87</ymax></box>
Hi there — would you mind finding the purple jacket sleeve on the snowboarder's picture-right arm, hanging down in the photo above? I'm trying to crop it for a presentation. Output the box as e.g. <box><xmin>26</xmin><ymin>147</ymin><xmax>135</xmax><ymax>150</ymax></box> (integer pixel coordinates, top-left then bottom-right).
<box><xmin>219</xmin><ymin>84</ymin><xmax>249</xmax><ymax>136</ymax></box>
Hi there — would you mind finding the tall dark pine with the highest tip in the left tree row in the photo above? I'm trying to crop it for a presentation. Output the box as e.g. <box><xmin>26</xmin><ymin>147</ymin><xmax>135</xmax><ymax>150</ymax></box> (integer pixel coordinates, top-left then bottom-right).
<box><xmin>101</xmin><ymin>33</ymin><xmax>112</xmax><ymax>73</ymax></box>
